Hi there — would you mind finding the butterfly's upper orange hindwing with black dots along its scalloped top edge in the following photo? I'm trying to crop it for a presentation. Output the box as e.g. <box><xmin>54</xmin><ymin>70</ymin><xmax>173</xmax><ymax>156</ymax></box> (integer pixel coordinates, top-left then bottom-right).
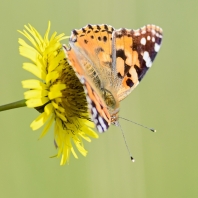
<box><xmin>69</xmin><ymin>25</ymin><xmax>114</xmax><ymax>89</ymax></box>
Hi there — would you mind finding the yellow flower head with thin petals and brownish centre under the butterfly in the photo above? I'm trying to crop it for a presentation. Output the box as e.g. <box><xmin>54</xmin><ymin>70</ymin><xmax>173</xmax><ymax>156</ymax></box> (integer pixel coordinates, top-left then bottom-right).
<box><xmin>19</xmin><ymin>22</ymin><xmax>98</xmax><ymax>165</ymax></box>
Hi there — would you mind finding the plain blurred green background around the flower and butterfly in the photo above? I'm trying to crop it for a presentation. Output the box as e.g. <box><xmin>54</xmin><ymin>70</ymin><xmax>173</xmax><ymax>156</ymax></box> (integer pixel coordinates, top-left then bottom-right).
<box><xmin>0</xmin><ymin>0</ymin><xmax>198</xmax><ymax>198</ymax></box>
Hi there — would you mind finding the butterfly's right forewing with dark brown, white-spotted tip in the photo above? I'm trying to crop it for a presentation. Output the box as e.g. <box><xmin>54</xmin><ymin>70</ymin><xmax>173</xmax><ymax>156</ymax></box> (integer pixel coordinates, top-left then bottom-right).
<box><xmin>112</xmin><ymin>25</ymin><xmax>162</xmax><ymax>101</ymax></box>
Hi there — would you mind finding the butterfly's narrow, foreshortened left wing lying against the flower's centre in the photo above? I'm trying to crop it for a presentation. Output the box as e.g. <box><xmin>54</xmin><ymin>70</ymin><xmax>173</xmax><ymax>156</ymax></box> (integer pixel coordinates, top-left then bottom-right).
<box><xmin>63</xmin><ymin>39</ymin><xmax>111</xmax><ymax>132</ymax></box>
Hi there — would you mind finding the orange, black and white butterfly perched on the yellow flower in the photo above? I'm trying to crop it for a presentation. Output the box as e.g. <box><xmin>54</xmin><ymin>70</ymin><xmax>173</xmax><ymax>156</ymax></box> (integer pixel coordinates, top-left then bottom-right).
<box><xmin>63</xmin><ymin>25</ymin><xmax>162</xmax><ymax>132</ymax></box>
